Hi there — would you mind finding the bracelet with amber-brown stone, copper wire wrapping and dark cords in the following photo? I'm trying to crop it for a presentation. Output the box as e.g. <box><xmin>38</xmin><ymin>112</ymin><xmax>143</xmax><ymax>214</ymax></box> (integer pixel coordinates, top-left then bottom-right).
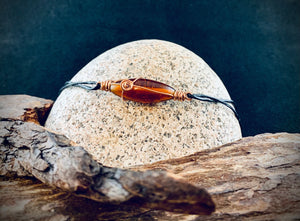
<box><xmin>60</xmin><ymin>78</ymin><xmax>239</xmax><ymax>120</ymax></box>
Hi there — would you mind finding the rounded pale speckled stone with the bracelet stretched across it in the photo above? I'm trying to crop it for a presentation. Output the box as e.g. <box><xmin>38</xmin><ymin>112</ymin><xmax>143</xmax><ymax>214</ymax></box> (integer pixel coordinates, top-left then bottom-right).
<box><xmin>46</xmin><ymin>40</ymin><xmax>241</xmax><ymax>167</ymax></box>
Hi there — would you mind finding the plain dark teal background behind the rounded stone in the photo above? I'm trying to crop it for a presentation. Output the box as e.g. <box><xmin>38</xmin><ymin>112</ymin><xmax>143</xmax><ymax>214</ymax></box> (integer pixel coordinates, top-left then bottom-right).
<box><xmin>0</xmin><ymin>0</ymin><xmax>300</xmax><ymax>136</ymax></box>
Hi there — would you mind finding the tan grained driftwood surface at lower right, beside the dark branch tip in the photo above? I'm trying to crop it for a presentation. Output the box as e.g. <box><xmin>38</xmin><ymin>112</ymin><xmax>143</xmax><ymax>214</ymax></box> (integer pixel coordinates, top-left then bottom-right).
<box><xmin>135</xmin><ymin>133</ymin><xmax>300</xmax><ymax>220</ymax></box>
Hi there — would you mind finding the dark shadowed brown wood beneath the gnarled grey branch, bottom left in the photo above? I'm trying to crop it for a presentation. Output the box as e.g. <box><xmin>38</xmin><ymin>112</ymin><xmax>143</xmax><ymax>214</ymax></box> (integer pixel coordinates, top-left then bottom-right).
<box><xmin>0</xmin><ymin>177</ymin><xmax>155</xmax><ymax>221</ymax></box>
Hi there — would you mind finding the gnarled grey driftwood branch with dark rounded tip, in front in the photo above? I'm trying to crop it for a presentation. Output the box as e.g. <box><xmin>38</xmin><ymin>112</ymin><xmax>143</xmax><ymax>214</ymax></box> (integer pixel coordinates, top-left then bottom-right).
<box><xmin>0</xmin><ymin>120</ymin><xmax>214</xmax><ymax>218</ymax></box>
